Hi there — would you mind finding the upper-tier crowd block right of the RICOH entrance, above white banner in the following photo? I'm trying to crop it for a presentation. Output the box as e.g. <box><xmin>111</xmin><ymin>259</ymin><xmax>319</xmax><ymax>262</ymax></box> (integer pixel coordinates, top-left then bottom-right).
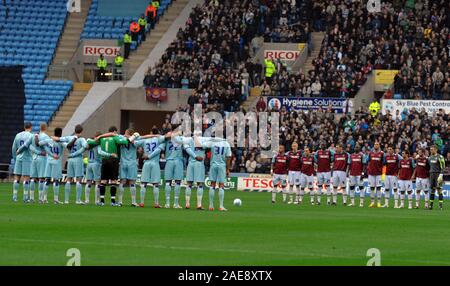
<box><xmin>314</xmin><ymin>0</ymin><xmax>450</xmax><ymax>99</ymax></box>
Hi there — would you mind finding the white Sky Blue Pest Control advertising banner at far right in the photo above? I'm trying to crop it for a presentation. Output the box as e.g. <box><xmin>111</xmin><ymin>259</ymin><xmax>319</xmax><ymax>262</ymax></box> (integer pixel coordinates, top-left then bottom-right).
<box><xmin>381</xmin><ymin>99</ymin><xmax>450</xmax><ymax>115</ymax></box>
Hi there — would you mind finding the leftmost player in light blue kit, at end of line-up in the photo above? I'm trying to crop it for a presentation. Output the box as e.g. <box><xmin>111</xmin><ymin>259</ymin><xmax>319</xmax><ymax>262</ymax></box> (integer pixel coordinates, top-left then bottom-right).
<box><xmin>12</xmin><ymin>122</ymin><xmax>33</xmax><ymax>202</ymax></box>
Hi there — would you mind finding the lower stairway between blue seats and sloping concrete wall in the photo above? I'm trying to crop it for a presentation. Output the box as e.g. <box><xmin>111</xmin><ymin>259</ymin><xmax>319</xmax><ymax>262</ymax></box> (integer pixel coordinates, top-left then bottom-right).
<box><xmin>48</xmin><ymin>83</ymin><xmax>92</xmax><ymax>134</ymax></box>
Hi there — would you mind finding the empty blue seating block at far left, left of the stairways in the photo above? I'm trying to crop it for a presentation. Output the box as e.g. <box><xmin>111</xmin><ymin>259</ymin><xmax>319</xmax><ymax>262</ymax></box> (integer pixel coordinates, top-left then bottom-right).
<box><xmin>0</xmin><ymin>0</ymin><xmax>72</xmax><ymax>130</ymax></box>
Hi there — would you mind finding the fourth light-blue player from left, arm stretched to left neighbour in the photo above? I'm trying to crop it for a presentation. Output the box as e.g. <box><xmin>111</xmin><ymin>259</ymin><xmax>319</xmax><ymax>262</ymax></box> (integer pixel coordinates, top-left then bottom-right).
<box><xmin>54</xmin><ymin>124</ymin><xmax>87</xmax><ymax>205</ymax></box>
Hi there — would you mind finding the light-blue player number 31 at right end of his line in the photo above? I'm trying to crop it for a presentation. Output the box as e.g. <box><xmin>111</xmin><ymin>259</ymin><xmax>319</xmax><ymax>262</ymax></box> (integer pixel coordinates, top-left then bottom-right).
<box><xmin>194</xmin><ymin>137</ymin><xmax>231</xmax><ymax>211</ymax></box>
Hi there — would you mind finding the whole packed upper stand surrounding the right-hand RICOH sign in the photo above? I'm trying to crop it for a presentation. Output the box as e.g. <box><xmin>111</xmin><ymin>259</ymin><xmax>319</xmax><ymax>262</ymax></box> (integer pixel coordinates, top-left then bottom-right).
<box><xmin>145</xmin><ymin>0</ymin><xmax>450</xmax><ymax>101</ymax></box>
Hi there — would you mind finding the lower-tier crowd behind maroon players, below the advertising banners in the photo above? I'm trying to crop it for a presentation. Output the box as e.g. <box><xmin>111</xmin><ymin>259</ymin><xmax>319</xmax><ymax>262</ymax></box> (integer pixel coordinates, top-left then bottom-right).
<box><xmin>163</xmin><ymin>100</ymin><xmax>450</xmax><ymax>175</ymax></box>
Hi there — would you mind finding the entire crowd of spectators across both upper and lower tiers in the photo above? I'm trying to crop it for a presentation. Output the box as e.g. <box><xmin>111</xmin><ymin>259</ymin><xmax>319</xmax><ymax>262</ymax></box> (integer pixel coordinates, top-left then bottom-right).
<box><xmin>144</xmin><ymin>0</ymin><xmax>450</xmax><ymax>173</ymax></box>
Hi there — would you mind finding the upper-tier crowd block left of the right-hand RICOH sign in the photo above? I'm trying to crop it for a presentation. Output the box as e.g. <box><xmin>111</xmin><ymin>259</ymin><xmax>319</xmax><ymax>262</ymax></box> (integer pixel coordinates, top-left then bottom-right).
<box><xmin>144</xmin><ymin>0</ymin><xmax>311</xmax><ymax>111</ymax></box>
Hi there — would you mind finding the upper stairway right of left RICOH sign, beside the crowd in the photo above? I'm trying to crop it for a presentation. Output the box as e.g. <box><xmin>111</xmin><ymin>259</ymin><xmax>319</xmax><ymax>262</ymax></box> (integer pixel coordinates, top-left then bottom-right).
<box><xmin>126</xmin><ymin>0</ymin><xmax>189</xmax><ymax>78</ymax></box>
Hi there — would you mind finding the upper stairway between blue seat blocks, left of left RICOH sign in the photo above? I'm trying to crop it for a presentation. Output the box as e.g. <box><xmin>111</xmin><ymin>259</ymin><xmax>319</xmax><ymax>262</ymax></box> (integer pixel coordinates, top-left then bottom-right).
<box><xmin>47</xmin><ymin>0</ymin><xmax>92</xmax><ymax>79</ymax></box>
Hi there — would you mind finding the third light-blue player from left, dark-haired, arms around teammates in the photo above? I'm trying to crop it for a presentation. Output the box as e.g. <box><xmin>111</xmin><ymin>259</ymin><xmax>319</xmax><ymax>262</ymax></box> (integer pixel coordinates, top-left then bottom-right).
<box><xmin>39</xmin><ymin>127</ymin><xmax>67</xmax><ymax>204</ymax></box>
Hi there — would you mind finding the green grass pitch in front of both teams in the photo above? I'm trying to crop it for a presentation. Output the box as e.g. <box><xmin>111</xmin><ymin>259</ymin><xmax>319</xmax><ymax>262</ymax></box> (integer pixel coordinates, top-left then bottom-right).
<box><xmin>0</xmin><ymin>184</ymin><xmax>450</xmax><ymax>266</ymax></box>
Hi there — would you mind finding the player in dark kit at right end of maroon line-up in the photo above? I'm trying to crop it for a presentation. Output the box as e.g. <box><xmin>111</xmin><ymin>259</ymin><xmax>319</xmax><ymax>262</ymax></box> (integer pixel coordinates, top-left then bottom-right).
<box><xmin>428</xmin><ymin>145</ymin><xmax>445</xmax><ymax>210</ymax></box>
